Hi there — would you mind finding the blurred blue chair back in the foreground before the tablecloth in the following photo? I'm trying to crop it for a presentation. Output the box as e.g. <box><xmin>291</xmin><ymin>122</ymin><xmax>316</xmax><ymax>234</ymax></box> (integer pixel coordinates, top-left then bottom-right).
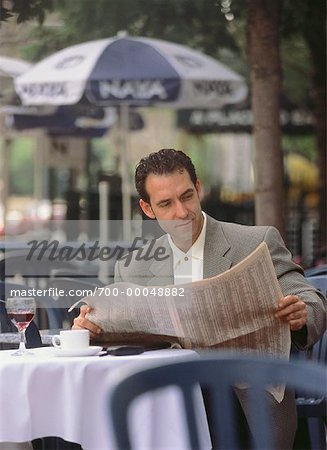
<box><xmin>108</xmin><ymin>352</ymin><xmax>327</xmax><ymax>450</ymax></box>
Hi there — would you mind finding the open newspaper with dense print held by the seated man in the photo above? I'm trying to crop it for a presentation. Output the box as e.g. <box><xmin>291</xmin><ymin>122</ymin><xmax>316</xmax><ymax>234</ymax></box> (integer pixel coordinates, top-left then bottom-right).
<box><xmin>83</xmin><ymin>243</ymin><xmax>290</xmax><ymax>358</ymax></box>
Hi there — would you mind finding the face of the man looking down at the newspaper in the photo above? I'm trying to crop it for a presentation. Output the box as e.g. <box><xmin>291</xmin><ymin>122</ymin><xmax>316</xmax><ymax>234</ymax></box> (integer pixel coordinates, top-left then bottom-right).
<box><xmin>140</xmin><ymin>169</ymin><xmax>203</xmax><ymax>251</ymax></box>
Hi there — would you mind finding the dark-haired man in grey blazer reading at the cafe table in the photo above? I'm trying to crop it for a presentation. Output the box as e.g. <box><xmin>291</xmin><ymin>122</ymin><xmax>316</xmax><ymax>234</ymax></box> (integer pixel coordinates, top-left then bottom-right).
<box><xmin>73</xmin><ymin>149</ymin><xmax>326</xmax><ymax>449</ymax></box>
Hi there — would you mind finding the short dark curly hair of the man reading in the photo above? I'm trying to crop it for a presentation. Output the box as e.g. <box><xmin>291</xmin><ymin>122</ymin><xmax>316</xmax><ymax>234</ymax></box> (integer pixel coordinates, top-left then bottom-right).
<box><xmin>135</xmin><ymin>148</ymin><xmax>197</xmax><ymax>203</ymax></box>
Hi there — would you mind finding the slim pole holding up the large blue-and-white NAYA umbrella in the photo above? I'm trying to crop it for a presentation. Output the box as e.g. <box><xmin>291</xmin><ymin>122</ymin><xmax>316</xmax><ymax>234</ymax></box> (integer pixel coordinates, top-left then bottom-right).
<box><xmin>119</xmin><ymin>102</ymin><xmax>131</xmax><ymax>241</ymax></box>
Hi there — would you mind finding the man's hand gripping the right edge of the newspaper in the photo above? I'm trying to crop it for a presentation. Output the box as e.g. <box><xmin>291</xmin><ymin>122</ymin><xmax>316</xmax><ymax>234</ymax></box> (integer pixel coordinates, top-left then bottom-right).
<box><xmin>275</xmin><ymin>295</ymin><xmax>308</xmax><ymax>331</ymax></box>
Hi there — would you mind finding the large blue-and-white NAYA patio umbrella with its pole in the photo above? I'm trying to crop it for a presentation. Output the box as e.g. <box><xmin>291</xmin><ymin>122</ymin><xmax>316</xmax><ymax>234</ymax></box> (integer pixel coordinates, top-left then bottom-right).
<box><xmin>15</xmin><ymin>33</ymin><xmax>247</xmax><ymax>236</ymax></box>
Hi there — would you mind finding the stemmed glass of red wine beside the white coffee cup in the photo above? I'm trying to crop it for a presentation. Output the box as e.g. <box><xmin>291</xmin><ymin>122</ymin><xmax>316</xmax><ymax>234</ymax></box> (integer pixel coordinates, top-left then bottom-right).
<box><xmin>6</xmin><ymin>297</ymin><xmax>36</xmax><ymax>356</ymax></box>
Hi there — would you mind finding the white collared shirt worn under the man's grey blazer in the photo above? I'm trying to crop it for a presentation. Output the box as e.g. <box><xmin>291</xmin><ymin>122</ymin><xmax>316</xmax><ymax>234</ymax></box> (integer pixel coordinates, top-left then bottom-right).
<box><xmin>168</xmin><ymin>211</ymin><xmax>207</xmax><ymax>284</ymax></box>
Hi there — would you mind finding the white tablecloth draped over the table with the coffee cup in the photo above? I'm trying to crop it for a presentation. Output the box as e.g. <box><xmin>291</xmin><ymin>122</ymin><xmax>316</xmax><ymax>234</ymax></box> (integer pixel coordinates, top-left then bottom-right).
<box><xmin>0</xmin><ymin>347</ymin><xmax>211</xmax><ymax>450</ymax></box>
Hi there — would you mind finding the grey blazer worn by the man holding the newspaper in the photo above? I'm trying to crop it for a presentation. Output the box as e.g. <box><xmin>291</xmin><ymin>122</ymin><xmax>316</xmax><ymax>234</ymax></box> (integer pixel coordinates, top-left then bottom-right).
<box><xmin>115</xmin><ymin>215</ymin><xmax>326</xmax><ymax>348</ymax></box>
